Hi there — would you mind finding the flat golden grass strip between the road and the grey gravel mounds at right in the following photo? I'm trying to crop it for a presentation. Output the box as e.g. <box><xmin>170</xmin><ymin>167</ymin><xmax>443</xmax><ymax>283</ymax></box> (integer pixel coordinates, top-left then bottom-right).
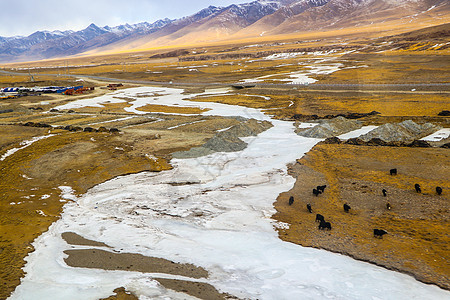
<box><xmin>188</xmin><ymin>88</ymin><xmax>448</xmax><ymax>123</ymax></box>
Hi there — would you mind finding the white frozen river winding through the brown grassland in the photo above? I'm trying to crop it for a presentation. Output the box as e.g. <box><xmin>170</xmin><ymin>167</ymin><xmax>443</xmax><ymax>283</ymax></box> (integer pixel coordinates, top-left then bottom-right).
<box><xmin>11</xmin><ymin>87</ymin><xmax>450</xmax><ymax>300</ymax></box>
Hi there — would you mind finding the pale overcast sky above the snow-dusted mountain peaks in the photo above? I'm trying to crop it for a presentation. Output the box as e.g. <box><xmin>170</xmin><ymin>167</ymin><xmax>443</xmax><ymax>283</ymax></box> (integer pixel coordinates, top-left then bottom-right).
<box><xmin>0</xmin><ymin>0</ymin><xmax>252</xmax><ymax>36</ymax></box>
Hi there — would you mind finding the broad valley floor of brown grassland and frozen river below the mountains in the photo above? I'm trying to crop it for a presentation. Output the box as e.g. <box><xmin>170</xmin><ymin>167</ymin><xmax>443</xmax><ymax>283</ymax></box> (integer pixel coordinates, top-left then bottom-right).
<box><xmin>0</xmin><ymin>41</ymin><xmax>450</xmax><ymax>299</ymax></box>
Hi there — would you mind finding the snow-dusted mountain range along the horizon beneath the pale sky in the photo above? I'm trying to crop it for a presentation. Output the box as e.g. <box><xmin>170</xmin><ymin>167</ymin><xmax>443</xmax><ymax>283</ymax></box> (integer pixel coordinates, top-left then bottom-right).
<box><xmin>0</xmin><ymin>0</ymin><xmax>450</xmax><ymax>62</ymax></box>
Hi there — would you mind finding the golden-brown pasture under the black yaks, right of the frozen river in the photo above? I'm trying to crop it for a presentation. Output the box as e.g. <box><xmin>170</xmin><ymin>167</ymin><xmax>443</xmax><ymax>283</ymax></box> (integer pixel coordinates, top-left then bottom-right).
<box><xmin>274</xmin><ymin>144</ymin><xmax>450</xmax><ymax>289</ymax></box>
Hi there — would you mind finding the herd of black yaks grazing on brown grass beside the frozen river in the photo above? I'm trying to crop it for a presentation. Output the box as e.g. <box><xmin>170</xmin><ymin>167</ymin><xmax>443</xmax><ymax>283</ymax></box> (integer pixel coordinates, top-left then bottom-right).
<box><xmin>289</xmin><ymin>169</ymin><xmax>442</xmax><ymax>238</ymax></box>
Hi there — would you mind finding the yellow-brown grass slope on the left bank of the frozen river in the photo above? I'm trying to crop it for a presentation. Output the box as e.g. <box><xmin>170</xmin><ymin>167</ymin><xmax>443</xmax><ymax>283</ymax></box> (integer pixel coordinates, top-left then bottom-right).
<box><xmin>0</xmin><ymin>126</ymin><xmax>170</xmax><ymax>298</ymax></box>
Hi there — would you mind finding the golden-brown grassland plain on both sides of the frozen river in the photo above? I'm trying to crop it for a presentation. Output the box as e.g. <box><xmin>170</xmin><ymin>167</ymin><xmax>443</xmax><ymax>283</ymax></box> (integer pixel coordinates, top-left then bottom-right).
<box><xmin>0</xmin><ymin>27</ymin><xmax>450</xmax><ymax>299</ymax></box>
